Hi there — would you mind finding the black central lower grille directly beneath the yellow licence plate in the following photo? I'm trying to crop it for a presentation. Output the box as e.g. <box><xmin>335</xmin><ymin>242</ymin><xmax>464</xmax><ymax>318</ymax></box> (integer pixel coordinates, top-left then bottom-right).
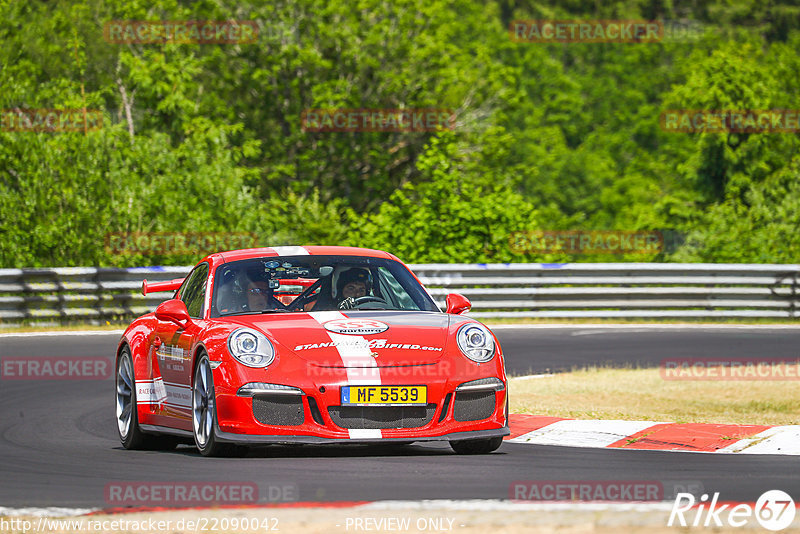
<box><xmin>328</xmin><ymin>404</ymin><xmax>436</xmax><ymax>428</ymax></box>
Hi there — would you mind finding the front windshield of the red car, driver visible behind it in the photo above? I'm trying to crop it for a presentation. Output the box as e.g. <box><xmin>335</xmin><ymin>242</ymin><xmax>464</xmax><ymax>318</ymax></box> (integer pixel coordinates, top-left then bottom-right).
<box><xmin>212</xmin><ymin>256</ymin><xmax>440</xmax><ymax>317</ymax></box>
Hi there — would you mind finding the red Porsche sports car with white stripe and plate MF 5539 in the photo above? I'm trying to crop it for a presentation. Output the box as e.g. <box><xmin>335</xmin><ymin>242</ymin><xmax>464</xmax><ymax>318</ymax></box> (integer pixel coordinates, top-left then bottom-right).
<box><xmin>116</xmin><ymin>247</ymin><xmax>509</xmax><ymax>456</ymax></box>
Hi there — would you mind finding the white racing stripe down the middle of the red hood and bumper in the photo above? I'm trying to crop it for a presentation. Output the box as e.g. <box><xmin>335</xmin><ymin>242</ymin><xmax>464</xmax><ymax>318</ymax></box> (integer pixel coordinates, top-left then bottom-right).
<box><xmin>309</xmin><ymin>311</ymin><xmax>383</xmax><ymax>439</ymax></box>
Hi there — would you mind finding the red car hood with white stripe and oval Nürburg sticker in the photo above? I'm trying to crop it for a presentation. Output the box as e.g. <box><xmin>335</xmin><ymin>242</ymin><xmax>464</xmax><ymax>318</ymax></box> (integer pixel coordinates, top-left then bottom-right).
<box><xmin>227</xmin><ymin>310</ymin><xmax>450</xmax><ymax>367</ymax></box>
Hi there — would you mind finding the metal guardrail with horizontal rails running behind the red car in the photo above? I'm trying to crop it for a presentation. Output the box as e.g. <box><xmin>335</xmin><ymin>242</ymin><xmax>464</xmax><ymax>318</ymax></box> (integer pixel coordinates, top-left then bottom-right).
<box><xmin>0</xmin><ymin>263</ymin><xmax>800</xmax><ymax>324</ymax></box>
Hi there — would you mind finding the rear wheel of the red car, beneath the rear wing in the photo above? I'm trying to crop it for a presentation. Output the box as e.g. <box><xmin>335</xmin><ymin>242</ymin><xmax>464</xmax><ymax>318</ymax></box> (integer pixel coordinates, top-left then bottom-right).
<box><xmin>114</xmin><ymin>347</ymin><xmax>179</xmax><ymax>451</ymax></box>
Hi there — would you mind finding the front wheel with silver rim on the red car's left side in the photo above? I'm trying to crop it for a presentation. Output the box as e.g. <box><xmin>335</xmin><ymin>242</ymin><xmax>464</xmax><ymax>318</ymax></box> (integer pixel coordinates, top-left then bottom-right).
<box><xmin>192</xmin><ymin>352</ymin><xmax>248</xmax><ymax>457</ymax></box>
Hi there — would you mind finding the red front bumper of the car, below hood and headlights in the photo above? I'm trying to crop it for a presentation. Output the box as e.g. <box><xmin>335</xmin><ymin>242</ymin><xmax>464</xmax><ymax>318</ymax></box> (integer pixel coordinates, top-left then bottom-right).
<box><xmin>214</xmin><ymin>358</ymin><xmax>510</xmax><ymax>444</ymax></box>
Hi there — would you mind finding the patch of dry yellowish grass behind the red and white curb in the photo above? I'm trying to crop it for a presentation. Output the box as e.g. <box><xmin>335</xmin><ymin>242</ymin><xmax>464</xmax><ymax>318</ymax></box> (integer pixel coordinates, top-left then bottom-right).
<box><xmin>508</xmin><ymin>367</ymin><xmax>800</xmax><ymax>425</ymax></box>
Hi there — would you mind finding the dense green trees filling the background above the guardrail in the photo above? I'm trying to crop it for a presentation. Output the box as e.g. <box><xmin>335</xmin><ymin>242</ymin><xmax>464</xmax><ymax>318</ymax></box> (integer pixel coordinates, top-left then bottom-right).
<box><xmin>0</xmin><ymin>0</ymin><xmax>800</xmax><ymax>268</ymax></box>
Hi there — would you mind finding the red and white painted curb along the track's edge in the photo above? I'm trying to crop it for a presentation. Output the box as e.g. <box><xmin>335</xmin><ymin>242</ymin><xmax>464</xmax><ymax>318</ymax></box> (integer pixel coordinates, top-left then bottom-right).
<box><xmin>505</xmin><ymin>414</ymin><xmax>800</xmax><ymax>455</ymax></box>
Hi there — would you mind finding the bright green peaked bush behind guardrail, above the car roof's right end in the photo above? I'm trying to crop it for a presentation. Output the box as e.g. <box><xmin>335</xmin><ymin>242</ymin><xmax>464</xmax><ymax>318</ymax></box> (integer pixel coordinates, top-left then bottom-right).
<box><xmin>351</xmin><ymin>133</ymin><xmax>537</xmax><ymax>262</ymax></box>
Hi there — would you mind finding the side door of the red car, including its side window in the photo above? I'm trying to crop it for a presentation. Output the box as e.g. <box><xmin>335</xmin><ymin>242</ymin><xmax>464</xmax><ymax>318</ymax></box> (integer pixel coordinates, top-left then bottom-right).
<box><xmin>151</xmin><ymin>263</ymin><xmax>209</xmax><ymax>429</ymax></box>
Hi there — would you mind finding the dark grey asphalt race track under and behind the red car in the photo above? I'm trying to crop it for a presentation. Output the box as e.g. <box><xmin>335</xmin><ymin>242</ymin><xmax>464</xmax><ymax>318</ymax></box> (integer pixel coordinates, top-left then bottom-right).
<box><xmin>0</xmin><ymin>326</ymin><xmax>800</xmax><ymax>508</ymax></box>
